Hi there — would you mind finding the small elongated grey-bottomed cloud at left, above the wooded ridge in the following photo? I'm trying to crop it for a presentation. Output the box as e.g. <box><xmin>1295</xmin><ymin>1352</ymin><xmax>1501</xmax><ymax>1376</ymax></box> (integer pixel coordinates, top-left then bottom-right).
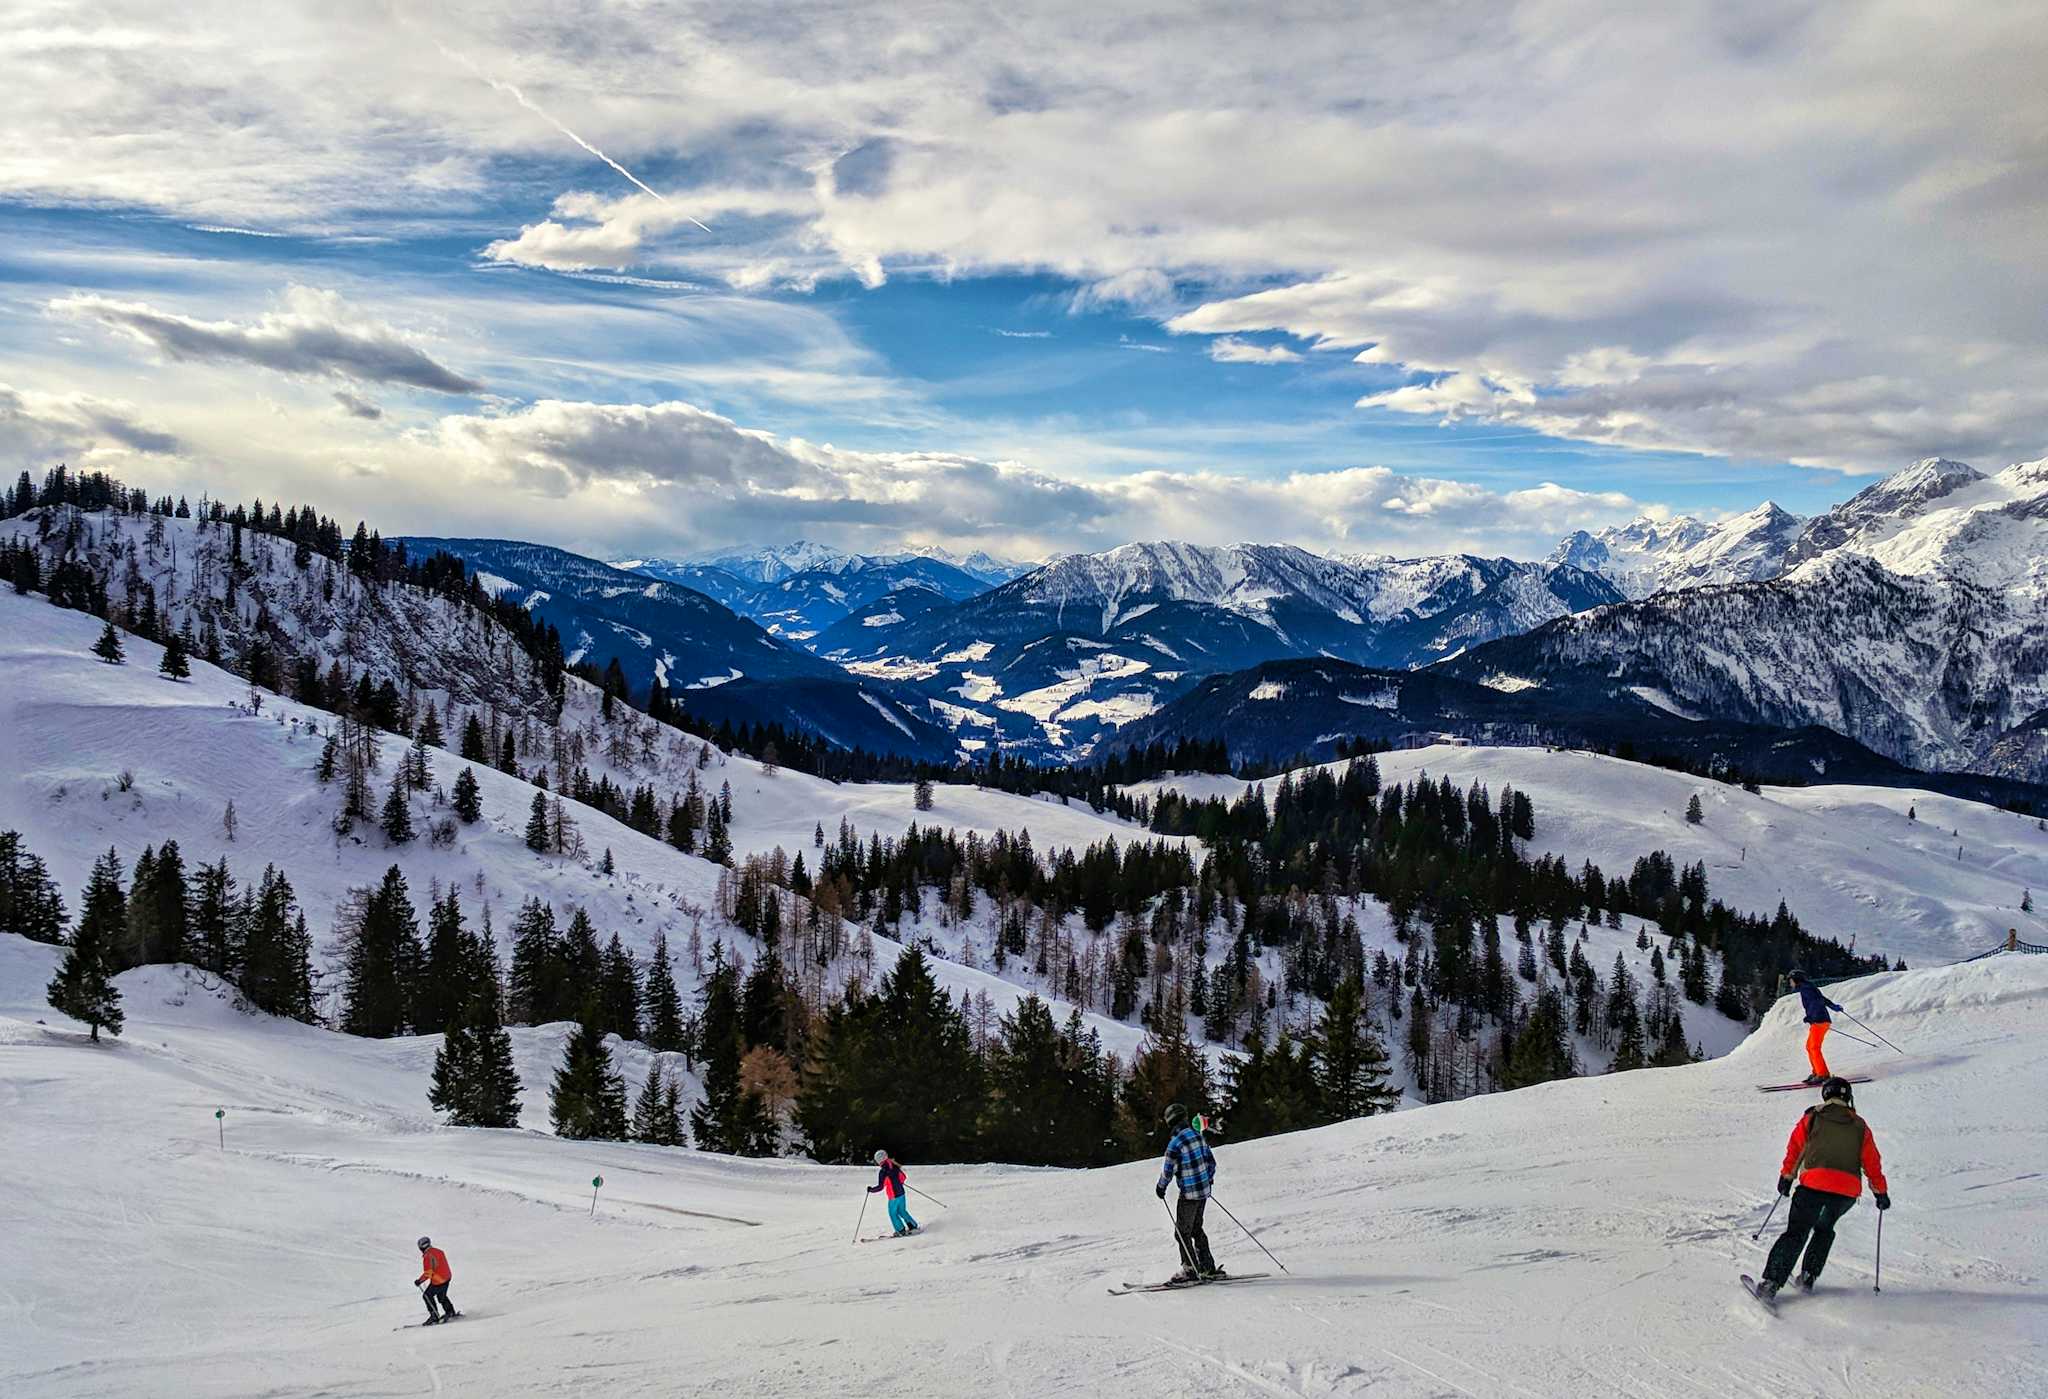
<box><xmin>47</xmin><ymin>287</ymin><xmax>483</xmax><ymax>393</ymax></box>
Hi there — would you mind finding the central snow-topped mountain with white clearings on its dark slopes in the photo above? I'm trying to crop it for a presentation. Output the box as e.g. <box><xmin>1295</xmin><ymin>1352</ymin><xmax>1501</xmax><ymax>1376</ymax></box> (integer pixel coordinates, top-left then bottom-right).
<box><xmin>815</xmin><ymin>543</ymin><xmax>1622</xmax><ymax>762</ymax></box>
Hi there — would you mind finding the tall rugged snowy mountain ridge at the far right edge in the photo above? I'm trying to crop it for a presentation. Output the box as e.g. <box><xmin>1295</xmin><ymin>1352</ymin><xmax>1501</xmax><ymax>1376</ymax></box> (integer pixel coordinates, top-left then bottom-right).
<box><xmin>1450</xmin><ymin>459</ymin><xmax>2048</xmax><ymax>782</ymax></box>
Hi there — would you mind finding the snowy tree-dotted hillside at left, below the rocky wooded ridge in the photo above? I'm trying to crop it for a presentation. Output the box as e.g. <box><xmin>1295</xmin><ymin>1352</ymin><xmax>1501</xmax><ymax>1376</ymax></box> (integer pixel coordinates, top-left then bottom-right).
<box><xmin>0</xmin><ymin>590</ymin><xmax>1179</xmax><ymax>1057</ymax></box>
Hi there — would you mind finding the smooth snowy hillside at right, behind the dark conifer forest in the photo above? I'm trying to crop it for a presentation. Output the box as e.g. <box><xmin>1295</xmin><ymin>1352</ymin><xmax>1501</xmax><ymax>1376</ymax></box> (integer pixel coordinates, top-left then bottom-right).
<box><xmin>1128</xmin><ymin>746</ymin><xmax>2048</xmax><ymax>967</ymax></box>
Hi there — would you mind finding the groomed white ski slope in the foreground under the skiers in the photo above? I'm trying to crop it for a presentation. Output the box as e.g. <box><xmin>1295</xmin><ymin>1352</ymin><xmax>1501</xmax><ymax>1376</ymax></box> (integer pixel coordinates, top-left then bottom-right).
<box><xmin>0</xmin><ymin>936</ymin><xmax>2048</xmax><ymax>1399</ymax></box>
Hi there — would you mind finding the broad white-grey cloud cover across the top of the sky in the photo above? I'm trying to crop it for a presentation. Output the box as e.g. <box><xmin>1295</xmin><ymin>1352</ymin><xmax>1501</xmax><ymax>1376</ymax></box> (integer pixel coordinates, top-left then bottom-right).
<box><xmin>0</xmin><ymin>0</ymin><xmax>2048</xmax><ymax>469</ymax></box>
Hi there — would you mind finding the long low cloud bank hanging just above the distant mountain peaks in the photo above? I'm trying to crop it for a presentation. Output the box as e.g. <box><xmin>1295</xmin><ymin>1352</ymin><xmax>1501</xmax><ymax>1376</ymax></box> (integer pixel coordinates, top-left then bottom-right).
<box><xmin>420</xmin><ymin>399</ymin><xmax>1642</xmax><ymax>557</ymax></box>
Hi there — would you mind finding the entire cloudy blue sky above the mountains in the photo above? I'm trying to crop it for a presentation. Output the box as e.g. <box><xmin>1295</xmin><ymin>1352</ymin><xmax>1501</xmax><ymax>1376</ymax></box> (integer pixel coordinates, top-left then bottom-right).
<box><xmin>0</xmin><ymin>4</ymin><xmax>2048</xmax><ymax>557</ymax></box>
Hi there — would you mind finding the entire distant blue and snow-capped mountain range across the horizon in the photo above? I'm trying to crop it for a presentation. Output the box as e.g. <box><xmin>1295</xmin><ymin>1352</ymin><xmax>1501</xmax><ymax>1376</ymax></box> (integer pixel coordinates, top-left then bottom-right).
<box><xmin>399</xmin><ymin>459</ymin><xmax>2048</xmax><ymax>780</ymax></box>
